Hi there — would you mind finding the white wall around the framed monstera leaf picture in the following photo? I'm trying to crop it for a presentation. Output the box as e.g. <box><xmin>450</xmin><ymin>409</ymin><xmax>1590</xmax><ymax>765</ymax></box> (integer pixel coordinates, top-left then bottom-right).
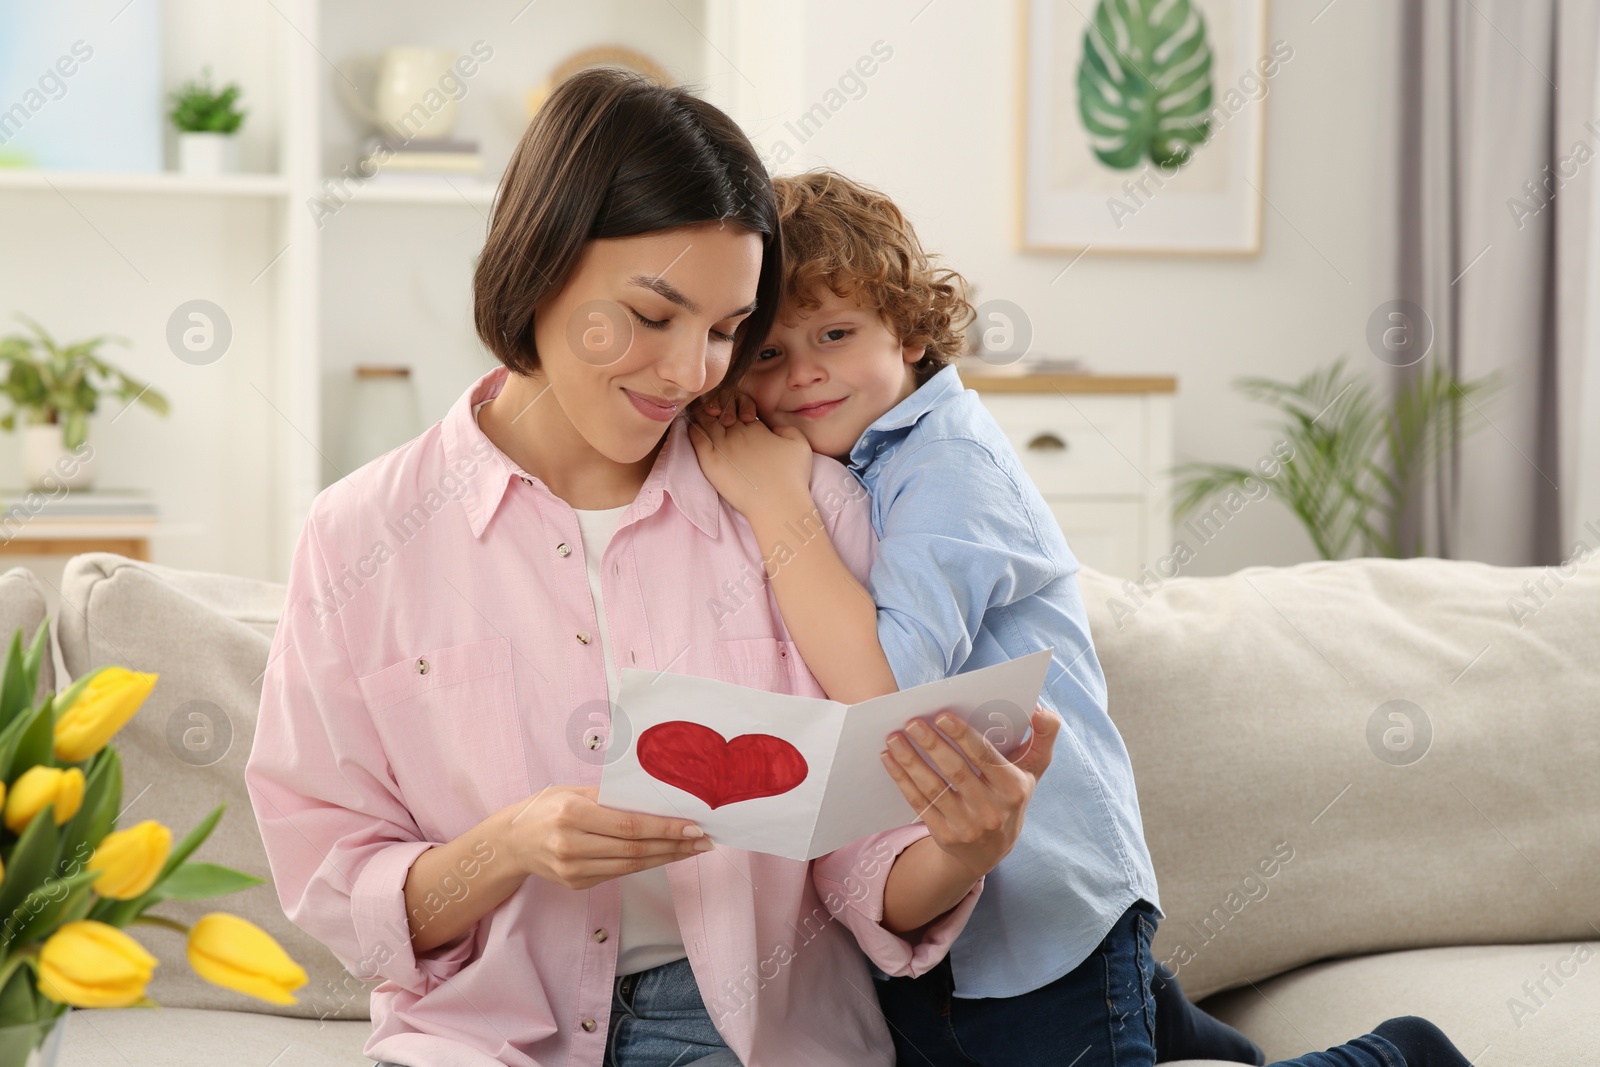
<box><xmin>750</xmin><ymin>0</ymin><xmax>1397</xmax><ymax>574</ymax></box>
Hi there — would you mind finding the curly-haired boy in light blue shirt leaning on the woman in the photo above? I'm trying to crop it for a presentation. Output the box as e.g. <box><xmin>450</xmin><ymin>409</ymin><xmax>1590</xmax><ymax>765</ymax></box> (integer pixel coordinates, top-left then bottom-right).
<box><xmin>691</xmin><ymin>171</ymin><xmax>1264</xmax><ymax>1067</ymax></box>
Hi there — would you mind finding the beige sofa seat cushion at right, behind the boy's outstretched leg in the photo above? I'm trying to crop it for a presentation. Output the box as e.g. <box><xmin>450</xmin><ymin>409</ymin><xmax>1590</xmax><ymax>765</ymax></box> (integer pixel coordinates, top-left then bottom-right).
<box><xmin>1205</xmin><ymin>934</ymin><xmax>1600</xmax><ymax>1065</ymax></box>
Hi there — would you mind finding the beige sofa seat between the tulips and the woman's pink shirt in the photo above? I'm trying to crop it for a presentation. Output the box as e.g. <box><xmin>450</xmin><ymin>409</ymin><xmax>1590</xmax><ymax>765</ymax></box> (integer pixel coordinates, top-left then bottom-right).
<box><xmin>59</xmin><ymin>1008</ymin><xmax>373</xmax><ymax>1067</ymax></box>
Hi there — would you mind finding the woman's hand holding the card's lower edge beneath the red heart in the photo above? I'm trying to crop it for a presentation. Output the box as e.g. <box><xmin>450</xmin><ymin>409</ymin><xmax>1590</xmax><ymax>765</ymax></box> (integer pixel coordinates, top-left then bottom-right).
<box><xmin>501</xmin><ymin>785</ymin><xmax>712</xmax><ymax>889</ymax></box>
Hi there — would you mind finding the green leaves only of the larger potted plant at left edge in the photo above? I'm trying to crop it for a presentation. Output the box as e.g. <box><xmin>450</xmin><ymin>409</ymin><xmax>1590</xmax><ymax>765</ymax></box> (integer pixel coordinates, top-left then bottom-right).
<box><xmin>0</xmin><ymin>315</ymin><xmax>168</xmax><ymax>450</ymax></box>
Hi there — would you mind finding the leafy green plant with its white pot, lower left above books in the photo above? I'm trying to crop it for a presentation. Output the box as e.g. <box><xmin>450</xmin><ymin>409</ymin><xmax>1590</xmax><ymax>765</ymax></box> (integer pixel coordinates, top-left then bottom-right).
<box><xmin>0</xmin><ymin>315</ymin><xmax>168</xmax><ymax>490</ymax></box>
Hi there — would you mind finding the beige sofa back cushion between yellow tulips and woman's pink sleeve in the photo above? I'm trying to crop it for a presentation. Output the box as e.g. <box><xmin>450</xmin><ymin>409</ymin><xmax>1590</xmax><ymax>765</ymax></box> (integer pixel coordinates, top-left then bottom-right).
<box><xmin>58</xmin><ymin>552</ymin><xmax>371</xmax><ymax>1023</ymax></box>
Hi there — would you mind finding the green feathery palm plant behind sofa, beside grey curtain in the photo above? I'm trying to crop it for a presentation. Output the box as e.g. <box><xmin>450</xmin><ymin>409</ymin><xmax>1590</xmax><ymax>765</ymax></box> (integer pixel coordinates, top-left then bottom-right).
<box><xmin>1174</xmin><ymin>357</ymin><xmax>1499</xmax><ymax>560</ymax></box>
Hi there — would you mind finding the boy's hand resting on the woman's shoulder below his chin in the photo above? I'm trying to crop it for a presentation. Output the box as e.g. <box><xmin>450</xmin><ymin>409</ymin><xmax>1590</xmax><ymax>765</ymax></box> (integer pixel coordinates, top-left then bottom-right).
<box><xmin>690</xmin><ymin>394</ymin><xmax>813</xmax><ymax>525</ymax></box>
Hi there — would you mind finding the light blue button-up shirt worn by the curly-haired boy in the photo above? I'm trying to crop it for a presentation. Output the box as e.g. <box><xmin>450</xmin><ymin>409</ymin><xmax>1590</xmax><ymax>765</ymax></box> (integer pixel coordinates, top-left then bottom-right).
<box><xmin>850</xmin><ymin>366</ymin><xmax>1160</xmax><ymax>997</ymax></box>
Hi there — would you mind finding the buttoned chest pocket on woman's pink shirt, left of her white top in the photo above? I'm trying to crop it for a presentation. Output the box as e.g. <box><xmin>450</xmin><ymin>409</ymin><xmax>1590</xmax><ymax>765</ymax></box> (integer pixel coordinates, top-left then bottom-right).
<box><xmin>357</xmin><ymin>637</ymin><xmax>531</xmax><ymax>840</ymax></box>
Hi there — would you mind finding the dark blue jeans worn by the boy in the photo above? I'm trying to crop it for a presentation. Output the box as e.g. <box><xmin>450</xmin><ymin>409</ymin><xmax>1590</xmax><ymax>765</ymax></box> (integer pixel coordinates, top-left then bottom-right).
<box><xmin>877</xmin><ymin>901</ymin><xmax>1406</xmax><ymax>1067</ymax></box>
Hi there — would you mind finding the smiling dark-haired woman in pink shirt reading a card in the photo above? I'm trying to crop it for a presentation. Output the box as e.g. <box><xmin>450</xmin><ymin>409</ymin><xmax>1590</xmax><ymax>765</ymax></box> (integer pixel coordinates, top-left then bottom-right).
<box><xmin>246</xmin><ymin>72</ymin><xmax>1472</xmax><ymax>1067</ymax></box>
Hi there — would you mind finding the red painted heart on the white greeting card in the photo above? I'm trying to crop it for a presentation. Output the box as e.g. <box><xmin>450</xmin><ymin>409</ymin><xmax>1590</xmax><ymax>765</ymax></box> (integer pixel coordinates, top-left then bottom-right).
<box><xmin>638</xmin><ymin>721</ymin><xmax>810</xmax><ymax>808</ymax></box>
